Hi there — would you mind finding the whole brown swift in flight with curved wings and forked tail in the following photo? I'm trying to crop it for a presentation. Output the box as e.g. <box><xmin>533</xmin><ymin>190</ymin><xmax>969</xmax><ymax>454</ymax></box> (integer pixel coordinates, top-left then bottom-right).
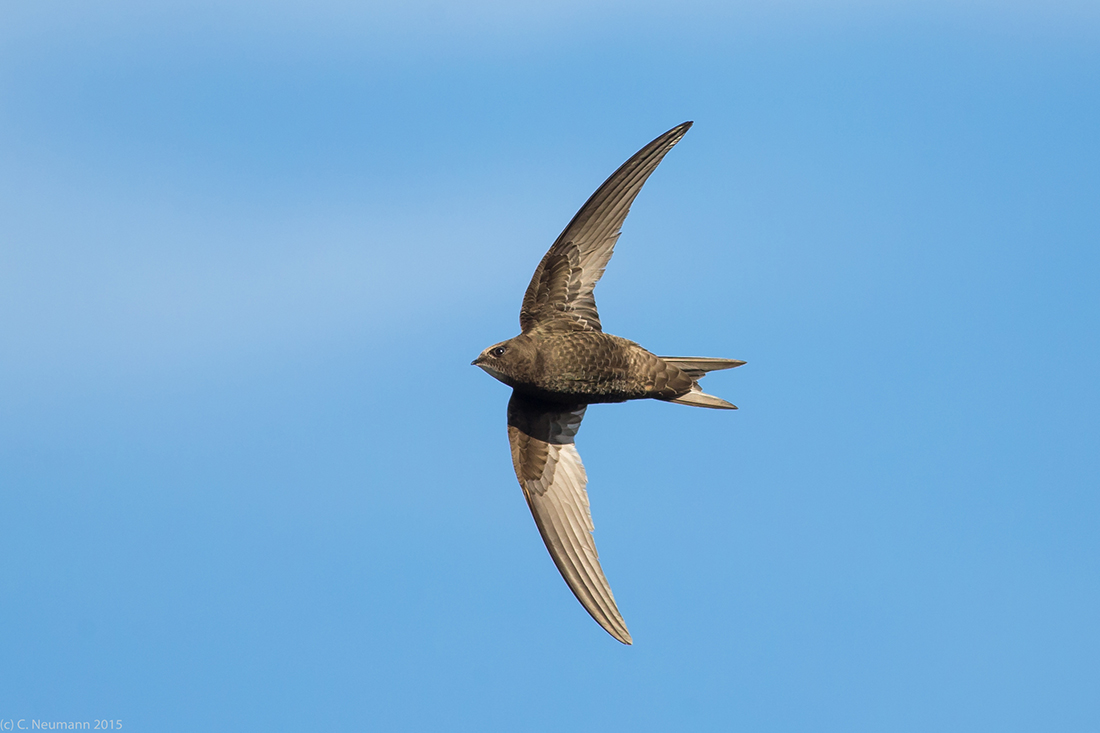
<box><xmin>471</xmin><ymin>121</ymin><xmax>746</xmax><ymax>645</ymax></box>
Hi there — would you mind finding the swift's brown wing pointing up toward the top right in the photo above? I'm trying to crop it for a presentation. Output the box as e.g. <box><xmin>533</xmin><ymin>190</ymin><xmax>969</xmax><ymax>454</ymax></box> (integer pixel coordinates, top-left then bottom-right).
<box><xmin>519</xmin><ymin>122</ymin><xmax>692</xmax><ymax>331</ymax></box>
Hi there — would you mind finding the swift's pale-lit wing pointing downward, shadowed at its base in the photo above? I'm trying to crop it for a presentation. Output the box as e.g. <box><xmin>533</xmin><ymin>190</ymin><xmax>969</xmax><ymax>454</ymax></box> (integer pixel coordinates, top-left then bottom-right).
<box><xmin>508</xmin><ymin>391</ymin><xmax>631</xmax><ymax>644</ymax></box>
